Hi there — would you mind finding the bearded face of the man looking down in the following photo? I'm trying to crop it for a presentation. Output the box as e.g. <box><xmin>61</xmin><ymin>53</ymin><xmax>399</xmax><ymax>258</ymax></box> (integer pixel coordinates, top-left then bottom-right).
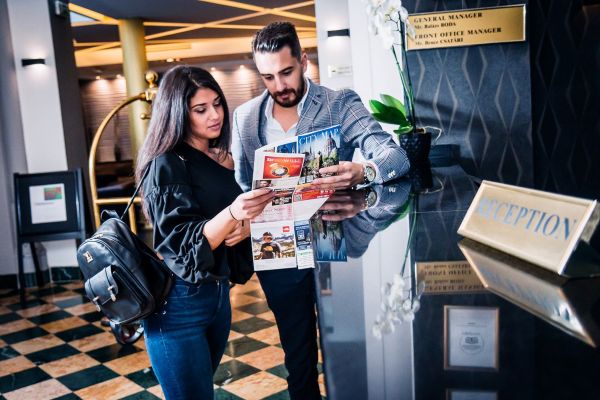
<box><xmin>254</xmin><ymin>46</ymin><xmax>307</xmax><ymax>107</ymax></box>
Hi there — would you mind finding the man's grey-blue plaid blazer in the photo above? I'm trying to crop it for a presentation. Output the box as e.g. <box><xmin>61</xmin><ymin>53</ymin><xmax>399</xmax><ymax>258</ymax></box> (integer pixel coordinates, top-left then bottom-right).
<box><xmin>231</xmin><ymin>82</ymin><xmax>409</xmax><ymax>192</ymax></box>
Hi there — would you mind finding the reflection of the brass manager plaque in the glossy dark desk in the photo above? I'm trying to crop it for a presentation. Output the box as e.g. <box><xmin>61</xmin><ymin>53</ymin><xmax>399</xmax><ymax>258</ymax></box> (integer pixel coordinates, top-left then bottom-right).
<box><xmin>417</xmin><ymin>261</ymin><xmax>485</xmax><ymax>294</ymax></box>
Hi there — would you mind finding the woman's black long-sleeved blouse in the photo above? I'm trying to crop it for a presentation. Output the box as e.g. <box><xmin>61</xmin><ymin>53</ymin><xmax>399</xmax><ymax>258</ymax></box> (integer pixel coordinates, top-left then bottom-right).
<box><xmin>143</xmin><ymin>143</ymin><xmax>252</xmax><ymax>284</ymax></box>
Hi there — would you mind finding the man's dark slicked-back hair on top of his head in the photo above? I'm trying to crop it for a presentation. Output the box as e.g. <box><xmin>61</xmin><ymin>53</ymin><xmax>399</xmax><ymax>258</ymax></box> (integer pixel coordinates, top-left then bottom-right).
<box><xmin>252</xmin><ymin>22</ymin><xmax>302</xmax><ymax>60</ymax></box>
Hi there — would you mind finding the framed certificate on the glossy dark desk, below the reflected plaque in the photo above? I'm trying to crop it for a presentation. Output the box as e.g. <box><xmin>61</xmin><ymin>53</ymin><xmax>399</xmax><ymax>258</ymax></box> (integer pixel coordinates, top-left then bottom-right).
<box><xmin>444</xmin><ymin>306</ymin><xmax>499</xmax><ymax>371</ymax></box>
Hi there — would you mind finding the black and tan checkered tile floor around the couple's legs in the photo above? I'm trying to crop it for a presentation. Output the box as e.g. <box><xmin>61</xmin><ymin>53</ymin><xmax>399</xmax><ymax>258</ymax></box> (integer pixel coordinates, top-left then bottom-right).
<box><xmin>0</xmin><ymin>278</ymin><xmax>325</xmax><ymax>400</ymax></box>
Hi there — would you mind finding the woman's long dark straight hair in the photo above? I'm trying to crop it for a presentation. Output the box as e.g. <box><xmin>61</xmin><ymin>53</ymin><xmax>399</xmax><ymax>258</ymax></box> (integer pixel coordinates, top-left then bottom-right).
<box><xmin>135</xmin><ymin>65</ymin><xmax>231</xmax><ymax>183</ymax></box>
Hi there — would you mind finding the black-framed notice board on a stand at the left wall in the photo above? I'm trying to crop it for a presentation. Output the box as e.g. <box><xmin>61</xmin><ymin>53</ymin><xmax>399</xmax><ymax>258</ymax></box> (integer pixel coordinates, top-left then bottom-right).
<box><xmin>14</xmin><ymin>169</ymin><xmax>85</xmax><ymax>237</ymax></box>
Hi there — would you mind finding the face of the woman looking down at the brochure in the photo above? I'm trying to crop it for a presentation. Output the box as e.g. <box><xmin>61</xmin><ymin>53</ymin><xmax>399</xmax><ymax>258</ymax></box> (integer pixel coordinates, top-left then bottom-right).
<box><xmin>189</xmin><ymin>88</ymin><xmax>224</xmax><ymax>140</ymax></box>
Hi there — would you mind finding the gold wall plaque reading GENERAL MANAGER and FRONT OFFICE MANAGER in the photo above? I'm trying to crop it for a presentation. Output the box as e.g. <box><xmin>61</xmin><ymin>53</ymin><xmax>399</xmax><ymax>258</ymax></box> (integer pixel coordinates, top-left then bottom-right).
<box><xmin>407</xmin><ymin>4</ymin><xmax>525</xmax><ymax>50</ymax></box>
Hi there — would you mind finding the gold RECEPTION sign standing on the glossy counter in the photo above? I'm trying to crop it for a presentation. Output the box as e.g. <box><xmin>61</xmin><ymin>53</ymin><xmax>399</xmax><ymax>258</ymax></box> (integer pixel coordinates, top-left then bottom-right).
<box><xmin>458</xmin><ymin>181</ymin><xmax>599</xmax><ymax>274</ymax></box>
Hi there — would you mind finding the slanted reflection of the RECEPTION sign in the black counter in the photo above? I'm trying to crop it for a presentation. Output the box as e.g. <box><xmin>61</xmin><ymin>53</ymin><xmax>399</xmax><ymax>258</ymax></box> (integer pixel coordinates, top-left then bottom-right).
<box><xmin>459</xmin><ymin>239</ymin><xmax>600</xmax><ymax>347</ymax></box>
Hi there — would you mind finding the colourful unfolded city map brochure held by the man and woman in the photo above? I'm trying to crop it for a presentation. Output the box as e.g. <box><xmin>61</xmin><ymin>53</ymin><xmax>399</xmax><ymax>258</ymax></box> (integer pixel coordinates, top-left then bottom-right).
<box><xmin>250</xmin><ymin>125</ymin><xmax>340</xmax><ymax>271</ymax></box>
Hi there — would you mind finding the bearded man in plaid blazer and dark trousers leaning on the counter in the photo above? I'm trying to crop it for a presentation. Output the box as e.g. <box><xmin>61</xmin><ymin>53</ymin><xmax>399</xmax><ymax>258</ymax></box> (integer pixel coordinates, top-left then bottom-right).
<box><xmin>232</xmin><ymin>22</ymin><xmax>409</xmax><ymax>400</ymax></box>
